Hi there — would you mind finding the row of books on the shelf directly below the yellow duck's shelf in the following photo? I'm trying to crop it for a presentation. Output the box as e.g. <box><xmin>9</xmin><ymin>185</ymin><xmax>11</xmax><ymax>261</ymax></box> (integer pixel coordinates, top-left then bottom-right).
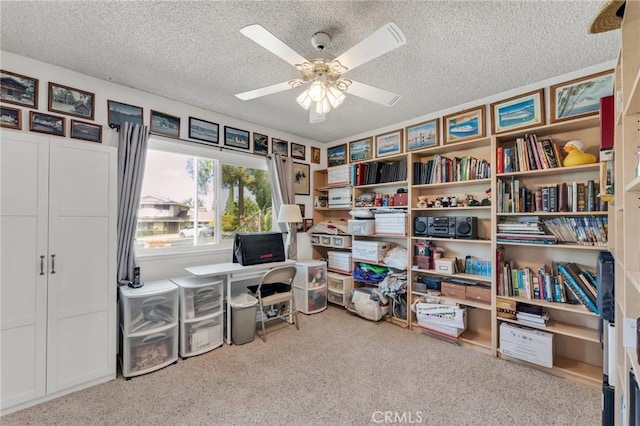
<box><xmin>497</xmin><ymin>177</ymin><xmax>607</xmax><ymax>213</ymax></box>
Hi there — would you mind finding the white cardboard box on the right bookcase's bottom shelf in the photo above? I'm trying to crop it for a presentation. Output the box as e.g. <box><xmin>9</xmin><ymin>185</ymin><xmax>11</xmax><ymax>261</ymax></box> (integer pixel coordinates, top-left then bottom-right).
<box><xmin>500</xmin><ymin>322</ymin><xmax>553</xmax><ymax>368</ymax></box>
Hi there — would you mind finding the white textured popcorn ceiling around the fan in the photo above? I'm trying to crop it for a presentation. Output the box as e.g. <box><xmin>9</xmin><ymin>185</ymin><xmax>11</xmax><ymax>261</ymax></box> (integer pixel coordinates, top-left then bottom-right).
<box><xmin>0</xmin><ymin>0</ymin><xmax>619</xmax><ymax>142</ymax></box>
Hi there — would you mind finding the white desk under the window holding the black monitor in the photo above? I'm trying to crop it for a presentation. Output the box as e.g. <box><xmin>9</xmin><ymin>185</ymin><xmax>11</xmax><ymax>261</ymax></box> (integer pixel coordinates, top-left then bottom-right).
<box><xmin>185</xmin><ymin>259</ymin><xmax>296</xmax><ymax>344</ymax></box>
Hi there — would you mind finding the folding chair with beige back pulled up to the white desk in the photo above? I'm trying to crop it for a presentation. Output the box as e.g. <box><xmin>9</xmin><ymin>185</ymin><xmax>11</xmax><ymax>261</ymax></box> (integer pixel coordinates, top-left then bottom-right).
<box><xmin>255</xmin><ymin>266</ymin><xmax>300</xmax><ymax>342</ymax></box>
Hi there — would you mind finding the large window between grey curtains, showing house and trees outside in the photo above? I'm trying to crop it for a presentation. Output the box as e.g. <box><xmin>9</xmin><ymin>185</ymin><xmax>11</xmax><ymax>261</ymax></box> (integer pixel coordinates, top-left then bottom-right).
<box><xmin>136</xmin><ymin>140</ymin><xmax>274</xmax><ymax>254</ymax></box>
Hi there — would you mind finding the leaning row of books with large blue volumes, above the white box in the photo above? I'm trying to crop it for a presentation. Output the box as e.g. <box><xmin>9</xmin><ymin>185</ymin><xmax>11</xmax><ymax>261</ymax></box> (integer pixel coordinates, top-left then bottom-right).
<box><xmin>498</xmin><ymin>261</ymin><xmax>598</xmax><ymax>314</ymax></box>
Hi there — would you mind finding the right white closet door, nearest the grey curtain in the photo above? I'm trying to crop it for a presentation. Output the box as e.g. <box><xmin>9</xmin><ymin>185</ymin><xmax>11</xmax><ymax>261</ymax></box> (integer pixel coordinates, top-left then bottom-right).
<box><xmin>47</xmin><ymin>141</ymin><xmax>117</xmax><ymax>393</ymax></box>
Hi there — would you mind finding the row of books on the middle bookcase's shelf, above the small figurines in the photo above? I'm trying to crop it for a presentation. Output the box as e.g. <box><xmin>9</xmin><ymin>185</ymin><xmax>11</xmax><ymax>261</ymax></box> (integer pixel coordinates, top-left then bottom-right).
<box><xmin>413</xmin><ymin>154</ymin><xmax>491</xmax><ymax>185</ymax></box>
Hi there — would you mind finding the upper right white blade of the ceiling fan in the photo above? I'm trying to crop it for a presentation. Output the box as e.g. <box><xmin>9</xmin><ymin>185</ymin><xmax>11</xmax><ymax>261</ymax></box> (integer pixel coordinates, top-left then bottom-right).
<box><xmin>335</xmin><ymin>22</ymin><xmax>407</xmax><ymax>71</ymax></box>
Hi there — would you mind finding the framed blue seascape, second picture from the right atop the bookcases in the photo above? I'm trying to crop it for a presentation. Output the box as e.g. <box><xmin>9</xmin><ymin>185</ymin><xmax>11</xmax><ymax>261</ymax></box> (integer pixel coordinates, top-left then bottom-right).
<box><xmin>490</xmin><ymin>89</ymin><xmax>546</xmax><ymax>135</ymax></box>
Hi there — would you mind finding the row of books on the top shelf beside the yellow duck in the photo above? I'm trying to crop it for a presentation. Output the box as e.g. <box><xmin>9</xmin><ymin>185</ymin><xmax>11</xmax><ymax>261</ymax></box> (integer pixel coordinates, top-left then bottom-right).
<box><xmin>496</xmin><ymin>133</ymin><xmax>563</xmax><ymax>173</ymax></box>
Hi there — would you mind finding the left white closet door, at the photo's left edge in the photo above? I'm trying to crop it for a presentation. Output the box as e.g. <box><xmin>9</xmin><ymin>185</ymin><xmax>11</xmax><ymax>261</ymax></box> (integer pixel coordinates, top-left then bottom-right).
<box><xmin>0</xmin><ymin>132</ymin><xmax>49</xmax><ymax>409</ymax></box>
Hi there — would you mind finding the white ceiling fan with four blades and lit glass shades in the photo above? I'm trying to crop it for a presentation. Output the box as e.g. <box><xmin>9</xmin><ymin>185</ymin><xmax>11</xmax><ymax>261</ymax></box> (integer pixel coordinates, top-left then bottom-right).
<box><xmin>236</xmin><ymin>22</ymin><xmax>407</xmax><ymax>123</ymax></box>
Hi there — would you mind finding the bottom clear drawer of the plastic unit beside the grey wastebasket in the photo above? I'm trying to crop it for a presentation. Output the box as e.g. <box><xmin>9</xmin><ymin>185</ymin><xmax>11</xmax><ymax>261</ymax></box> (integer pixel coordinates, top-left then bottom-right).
<box><xmin>180</xmin><ymin>311</ymin><xmax>223</xmax><ymax>357</ymax></box>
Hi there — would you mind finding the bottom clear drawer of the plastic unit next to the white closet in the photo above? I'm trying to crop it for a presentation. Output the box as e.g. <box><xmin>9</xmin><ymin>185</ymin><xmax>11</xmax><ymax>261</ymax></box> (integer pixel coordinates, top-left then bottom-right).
<box><xmin>121</xmin><ymin>326</ymin><xmax>178</xmax><ymax>377</ymax></box>
